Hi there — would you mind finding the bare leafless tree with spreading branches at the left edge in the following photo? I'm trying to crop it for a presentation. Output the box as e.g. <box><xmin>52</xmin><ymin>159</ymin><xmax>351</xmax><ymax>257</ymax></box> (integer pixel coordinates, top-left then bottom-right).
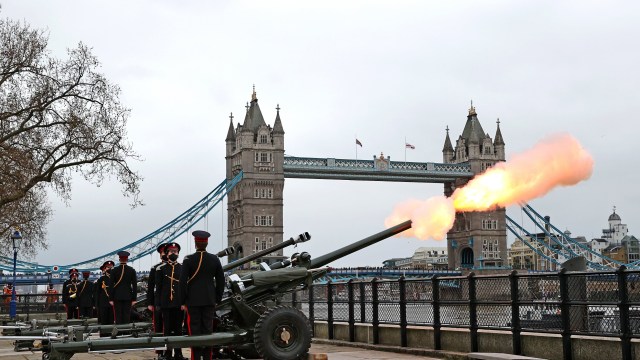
<box><xmin>0</xmin><ymin>19</ymin><xmax>142</xmax><ymax>253</ymax></box>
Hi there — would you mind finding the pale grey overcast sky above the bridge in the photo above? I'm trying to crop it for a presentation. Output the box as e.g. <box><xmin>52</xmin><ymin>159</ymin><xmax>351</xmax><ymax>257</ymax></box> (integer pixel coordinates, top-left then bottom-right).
<box><xmin>0</xmin><ymin>0</ymin><xmax>640</xmax><ymax>269</ymax></box>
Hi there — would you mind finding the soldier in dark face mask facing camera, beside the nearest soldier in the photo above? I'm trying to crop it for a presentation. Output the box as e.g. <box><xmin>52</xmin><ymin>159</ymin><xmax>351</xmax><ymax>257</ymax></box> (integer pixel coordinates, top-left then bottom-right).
<box><xmin>155</xmin><ymin>243</ymin><xmax>184</xmax><ymax>360</ymax></box>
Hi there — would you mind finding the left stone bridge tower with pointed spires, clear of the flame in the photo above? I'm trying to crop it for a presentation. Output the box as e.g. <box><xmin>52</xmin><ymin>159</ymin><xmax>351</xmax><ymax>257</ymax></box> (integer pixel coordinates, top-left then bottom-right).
<box><xmin>225</xmin><ymin>86</ymin><xmax>284</xmax><ymax>264</ymax></box>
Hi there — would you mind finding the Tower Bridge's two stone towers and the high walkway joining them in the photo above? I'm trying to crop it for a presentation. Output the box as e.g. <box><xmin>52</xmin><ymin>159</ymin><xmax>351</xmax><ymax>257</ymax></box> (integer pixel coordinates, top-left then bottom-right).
<box><xmin>225</xmin><ymin>88</ymin><xmax>507</xmax><ymax>269</ymax></box>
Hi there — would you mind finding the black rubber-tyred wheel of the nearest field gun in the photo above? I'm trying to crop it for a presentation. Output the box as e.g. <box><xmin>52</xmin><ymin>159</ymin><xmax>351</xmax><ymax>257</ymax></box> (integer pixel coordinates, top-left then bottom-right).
<box><xmin>253</xmin><ymin>306</ymin><xmax>311</xmax><ymax>360</ymax></box>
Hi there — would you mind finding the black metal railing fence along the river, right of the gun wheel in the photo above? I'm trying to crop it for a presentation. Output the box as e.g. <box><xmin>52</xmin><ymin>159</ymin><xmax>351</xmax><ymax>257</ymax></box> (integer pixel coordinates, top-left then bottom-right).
<box><xmin>291</xmin><ymin>266</ymin><xmax>640</xmax><ymax>360</ymax></box>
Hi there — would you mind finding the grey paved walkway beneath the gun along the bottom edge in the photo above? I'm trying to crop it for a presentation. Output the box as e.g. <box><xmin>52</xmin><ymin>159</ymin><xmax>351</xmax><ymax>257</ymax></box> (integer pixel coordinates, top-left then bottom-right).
<box><xmin>0</xmin><ymin>341</ymin><xmax>448</xmax><ymax>360</ymax></box>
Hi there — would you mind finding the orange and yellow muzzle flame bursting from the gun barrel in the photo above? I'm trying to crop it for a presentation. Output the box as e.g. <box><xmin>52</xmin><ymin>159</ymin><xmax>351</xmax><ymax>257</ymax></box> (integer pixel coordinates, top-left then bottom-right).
<box><xmin>385</xmin><ymin>134</ymin><xmax>593</xmax><ymax>240</ymax></box>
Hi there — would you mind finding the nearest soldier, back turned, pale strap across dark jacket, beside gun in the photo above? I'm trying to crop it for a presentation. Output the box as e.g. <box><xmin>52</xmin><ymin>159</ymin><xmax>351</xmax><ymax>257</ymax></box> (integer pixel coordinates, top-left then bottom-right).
<box><xmin>180</xmin><ymin>230</ymin><xmax>224</xmax><ymax>360</ymax></box>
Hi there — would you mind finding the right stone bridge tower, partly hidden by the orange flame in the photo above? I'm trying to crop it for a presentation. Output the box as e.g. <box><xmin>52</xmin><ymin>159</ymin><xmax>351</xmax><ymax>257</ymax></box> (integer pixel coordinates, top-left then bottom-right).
<box><xmin>442</xmin><ymin>102</ymin><xmax>507</xmax><ymax>269</ymax></box>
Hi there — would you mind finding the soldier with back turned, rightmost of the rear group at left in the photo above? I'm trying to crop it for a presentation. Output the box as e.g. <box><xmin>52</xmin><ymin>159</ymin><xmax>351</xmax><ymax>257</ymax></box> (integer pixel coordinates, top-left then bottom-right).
<box><xmin>109</xmin><ymin>251</ymin><xmax>138</xmax><ymax>324</ymax></box>
